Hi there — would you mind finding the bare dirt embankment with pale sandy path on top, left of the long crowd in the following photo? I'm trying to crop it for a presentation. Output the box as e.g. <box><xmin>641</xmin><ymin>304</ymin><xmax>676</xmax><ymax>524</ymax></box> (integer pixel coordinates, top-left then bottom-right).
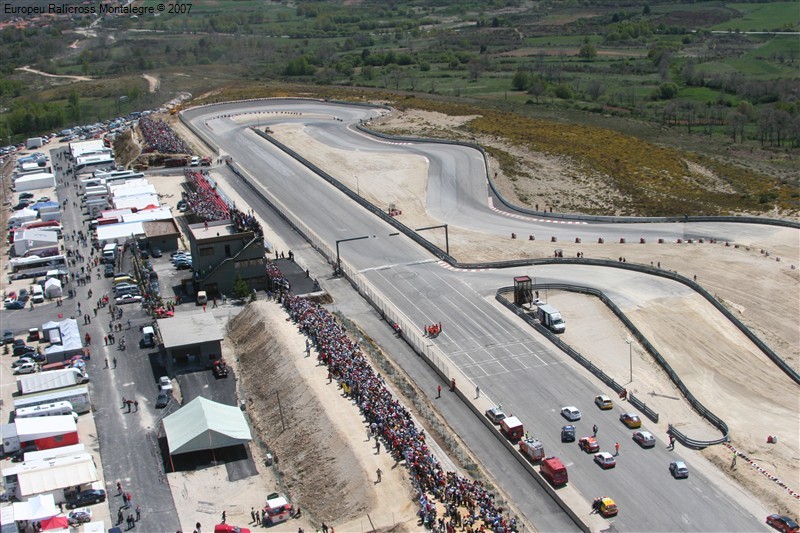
<box><xmin>230</xmin><ymin>301</ymin><xmax>416</xmax><ymax>531</ymax></box>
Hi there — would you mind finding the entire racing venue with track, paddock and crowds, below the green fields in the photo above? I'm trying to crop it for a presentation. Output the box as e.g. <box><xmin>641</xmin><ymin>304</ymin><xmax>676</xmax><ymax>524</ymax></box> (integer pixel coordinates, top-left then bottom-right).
<box><xmin>0</xmin><ymin>95</ymin><xmax>800</xmax><ymax>532</ymax></box>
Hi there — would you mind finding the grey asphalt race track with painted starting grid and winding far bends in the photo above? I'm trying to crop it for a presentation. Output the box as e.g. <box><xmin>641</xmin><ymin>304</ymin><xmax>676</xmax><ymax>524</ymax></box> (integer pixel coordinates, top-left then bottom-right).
<box><xmin>185</xmin><ymin>100</ymin><xmax>778</xmax><ymax>531</ymax></box>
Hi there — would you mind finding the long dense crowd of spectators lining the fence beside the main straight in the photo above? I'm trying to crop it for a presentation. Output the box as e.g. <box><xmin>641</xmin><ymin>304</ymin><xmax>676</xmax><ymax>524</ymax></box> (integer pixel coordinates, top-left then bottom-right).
<box><xmin>278</xmin><ymin>288</ymin><xmax>517</xmax><ymax>533</ymax></box>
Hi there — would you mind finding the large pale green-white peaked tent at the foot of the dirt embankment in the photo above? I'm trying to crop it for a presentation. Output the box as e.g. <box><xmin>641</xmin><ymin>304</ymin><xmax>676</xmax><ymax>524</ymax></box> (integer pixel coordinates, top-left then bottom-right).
<box><xmin>164</xmin><ymin>396</ymin><xmax>252</xmax><ymax>455</ymax></box>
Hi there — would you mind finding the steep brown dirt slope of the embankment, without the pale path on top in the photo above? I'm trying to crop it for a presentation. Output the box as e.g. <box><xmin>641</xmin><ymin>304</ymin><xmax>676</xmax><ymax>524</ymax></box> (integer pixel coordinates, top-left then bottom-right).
<box><xmin>225</xmin><ymin>302</ymin><xmax>376</xmax><ymax>524</ymax></box>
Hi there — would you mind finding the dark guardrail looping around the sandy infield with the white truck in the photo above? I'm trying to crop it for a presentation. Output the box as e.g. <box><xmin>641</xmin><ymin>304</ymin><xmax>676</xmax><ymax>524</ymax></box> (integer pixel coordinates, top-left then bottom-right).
<box><xmin>495</xmin><ymin>283</ymin><xmax>729</xmax><ymax>449</ymax></box>
